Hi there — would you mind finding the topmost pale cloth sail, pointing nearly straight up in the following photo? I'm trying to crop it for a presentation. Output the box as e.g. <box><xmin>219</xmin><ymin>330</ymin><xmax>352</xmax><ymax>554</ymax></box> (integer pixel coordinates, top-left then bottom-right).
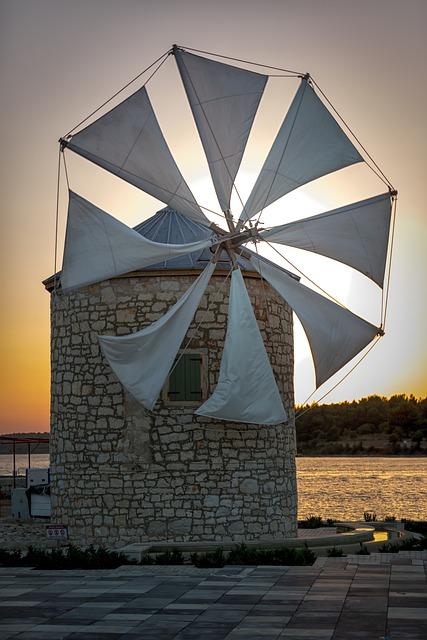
<box><xmin>175</xmin><ymin>49</ymin><xmax>268</xmax><ymax>211</ymax></box>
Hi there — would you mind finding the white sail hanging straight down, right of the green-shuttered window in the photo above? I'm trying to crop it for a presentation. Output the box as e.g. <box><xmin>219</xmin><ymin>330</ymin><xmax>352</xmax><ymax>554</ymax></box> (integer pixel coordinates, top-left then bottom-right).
<box><xmin>196</xmin><ymin>269</ymin><xmax>288</xmax><ymax>424</ymax></box>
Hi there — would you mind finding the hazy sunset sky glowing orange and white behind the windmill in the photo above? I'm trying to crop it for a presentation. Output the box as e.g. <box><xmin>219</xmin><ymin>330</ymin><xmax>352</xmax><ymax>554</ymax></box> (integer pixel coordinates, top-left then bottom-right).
<box><xmin>0</xmin><ymin>0</ymin><xmax>427</xmax><ymax>432</ymax></box>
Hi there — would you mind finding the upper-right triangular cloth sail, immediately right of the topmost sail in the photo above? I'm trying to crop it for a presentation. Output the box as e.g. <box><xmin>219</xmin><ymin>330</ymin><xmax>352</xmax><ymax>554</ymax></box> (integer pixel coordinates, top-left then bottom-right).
<box><xmin>240</xmin><ymin>78</ymin><xmax>363</xmax><ymax>222</ymax></box>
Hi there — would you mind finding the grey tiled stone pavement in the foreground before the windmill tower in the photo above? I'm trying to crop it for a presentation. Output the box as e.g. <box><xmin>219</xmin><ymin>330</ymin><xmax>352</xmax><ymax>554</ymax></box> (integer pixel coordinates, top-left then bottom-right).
<box><xmin>0</xmin><ymin>552</ymin><xmax>427</xmax><ymax>640</ymax></box>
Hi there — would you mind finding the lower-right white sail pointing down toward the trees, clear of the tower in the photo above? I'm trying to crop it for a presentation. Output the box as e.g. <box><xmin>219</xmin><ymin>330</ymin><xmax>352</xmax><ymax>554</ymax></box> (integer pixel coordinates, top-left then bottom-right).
<box><xmin>251</xmin><ymin>257</ymin><xmax>379</xmax><ymax>388</ymax></box>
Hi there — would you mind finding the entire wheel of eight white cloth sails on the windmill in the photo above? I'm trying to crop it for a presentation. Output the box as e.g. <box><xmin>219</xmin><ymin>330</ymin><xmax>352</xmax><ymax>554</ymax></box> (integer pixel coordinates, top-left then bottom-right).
<box><xmin>55</xmin><ymin>45</ymin><xmax>397</xmax><ymax>425</ymax></box>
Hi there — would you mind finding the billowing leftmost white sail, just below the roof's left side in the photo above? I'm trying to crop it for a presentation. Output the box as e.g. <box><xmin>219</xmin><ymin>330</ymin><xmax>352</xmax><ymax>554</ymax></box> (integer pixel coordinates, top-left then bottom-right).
<box><xmin>61</xmin><ymin>191</ymin><xmax>215</xmax><ymax>292</ymax></box>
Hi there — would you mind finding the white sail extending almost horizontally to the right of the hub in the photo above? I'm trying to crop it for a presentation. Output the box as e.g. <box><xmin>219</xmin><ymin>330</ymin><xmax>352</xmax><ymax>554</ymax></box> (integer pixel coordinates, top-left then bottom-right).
<box><xmin>259</xmin><ymin>193</ymin><xmax>391</xmax><ymax>287</ymax></box>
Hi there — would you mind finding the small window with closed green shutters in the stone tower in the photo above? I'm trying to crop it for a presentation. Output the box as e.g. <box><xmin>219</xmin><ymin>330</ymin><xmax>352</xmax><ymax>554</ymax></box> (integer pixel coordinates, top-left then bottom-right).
<box><xmin>164</xmin><ymin>351</ymin><xmax>206</xmax><ymax>404</ymax></box>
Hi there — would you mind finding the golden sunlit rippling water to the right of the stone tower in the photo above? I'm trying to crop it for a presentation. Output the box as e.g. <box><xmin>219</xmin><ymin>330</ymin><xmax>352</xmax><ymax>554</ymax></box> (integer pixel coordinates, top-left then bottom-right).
<box><xmin>297</xmin><ymin>456</ymin><xmax>427</xmax><ymax>520</ymax></box>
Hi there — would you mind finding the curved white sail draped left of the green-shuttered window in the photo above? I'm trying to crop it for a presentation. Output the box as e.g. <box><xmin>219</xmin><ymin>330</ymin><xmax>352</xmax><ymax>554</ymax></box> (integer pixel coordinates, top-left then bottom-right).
<box><xmin>98</xmin><ymin>263</ymin><xmax>215</xmax><ymax>409</ymax></box>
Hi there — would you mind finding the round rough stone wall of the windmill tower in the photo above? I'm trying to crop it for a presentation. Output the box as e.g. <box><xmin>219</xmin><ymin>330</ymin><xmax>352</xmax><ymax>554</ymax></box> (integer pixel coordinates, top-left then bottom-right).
<box><xmin>51</xmin><ymin>271</ymin><xmax>296</xmax><ymax>545</ymax></box>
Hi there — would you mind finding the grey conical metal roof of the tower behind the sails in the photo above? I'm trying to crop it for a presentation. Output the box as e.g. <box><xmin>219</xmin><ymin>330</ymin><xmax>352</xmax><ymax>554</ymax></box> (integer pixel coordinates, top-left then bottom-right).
<box><xmin>134</xmin><ymin>207</ymin><xmax>255</xmax><ymax>271</ymax></box>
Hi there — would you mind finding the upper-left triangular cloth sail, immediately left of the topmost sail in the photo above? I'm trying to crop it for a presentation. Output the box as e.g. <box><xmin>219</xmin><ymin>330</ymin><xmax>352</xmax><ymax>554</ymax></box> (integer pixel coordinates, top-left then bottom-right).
<box><xmin>68</xmin><ymin>87</ymin><xmax>207</xmax><ymax>223</ymax></box>
